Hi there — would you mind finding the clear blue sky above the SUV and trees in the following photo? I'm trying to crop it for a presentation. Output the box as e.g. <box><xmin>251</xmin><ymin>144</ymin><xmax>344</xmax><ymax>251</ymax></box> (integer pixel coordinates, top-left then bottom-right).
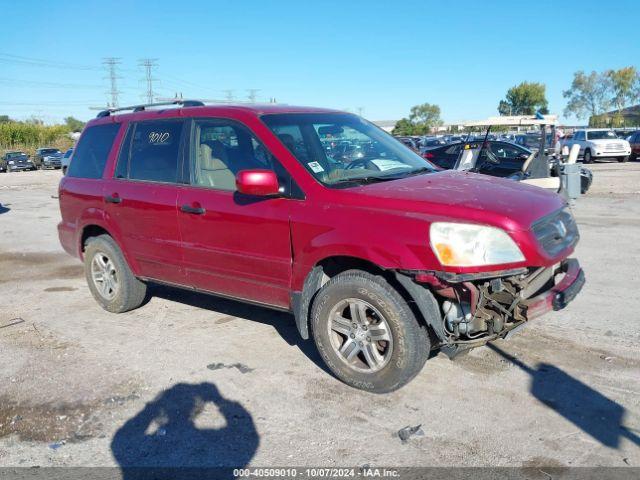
<box><xmin>0</xmin><ymin>0</ymin><xmax>640</xmax><ymax>123</ymax></box>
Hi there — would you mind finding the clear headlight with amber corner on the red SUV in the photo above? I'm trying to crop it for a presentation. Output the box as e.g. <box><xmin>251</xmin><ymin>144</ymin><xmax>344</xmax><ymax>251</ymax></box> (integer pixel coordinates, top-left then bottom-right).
<box><xmin>430</xmin><ymin>222</ymin><xmax>524</xmax><ymax>267</ymax></box>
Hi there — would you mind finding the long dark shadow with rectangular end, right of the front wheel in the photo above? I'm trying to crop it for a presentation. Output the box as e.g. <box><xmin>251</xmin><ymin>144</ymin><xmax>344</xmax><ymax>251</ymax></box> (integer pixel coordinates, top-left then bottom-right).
<box><xmin>488</xmin><ymin>343</ymin><xmax>640</xmax><ymax>448</ymax></box>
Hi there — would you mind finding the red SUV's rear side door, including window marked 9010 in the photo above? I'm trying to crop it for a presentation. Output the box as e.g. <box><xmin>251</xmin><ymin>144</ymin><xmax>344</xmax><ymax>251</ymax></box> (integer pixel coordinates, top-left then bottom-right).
<box><xmin>102</xmin><ymin>119</ymin><xmax>186</xmax><ymax>285</ymax></box>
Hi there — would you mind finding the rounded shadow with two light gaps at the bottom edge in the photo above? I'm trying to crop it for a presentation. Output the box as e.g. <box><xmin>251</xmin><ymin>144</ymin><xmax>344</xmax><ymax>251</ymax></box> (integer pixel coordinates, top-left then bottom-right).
<box><xmin>111</xmin><ymin>383</ymin><xmax>259</xmax><ymax>480</ymax></box>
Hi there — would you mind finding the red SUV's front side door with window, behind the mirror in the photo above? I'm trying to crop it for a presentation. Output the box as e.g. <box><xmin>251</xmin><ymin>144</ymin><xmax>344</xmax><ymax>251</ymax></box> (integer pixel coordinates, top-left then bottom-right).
<box><xmin>178</xmin><ymin>119</ymin><xmax>292</xmax><ymax>308</ymax></box>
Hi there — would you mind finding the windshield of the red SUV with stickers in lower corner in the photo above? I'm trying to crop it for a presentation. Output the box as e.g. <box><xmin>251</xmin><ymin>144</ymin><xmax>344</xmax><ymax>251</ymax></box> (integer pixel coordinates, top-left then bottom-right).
<box><xmin>262</xmin><ymin>113</ymin><xmax>436</xmax><ymax>186</ymax></box>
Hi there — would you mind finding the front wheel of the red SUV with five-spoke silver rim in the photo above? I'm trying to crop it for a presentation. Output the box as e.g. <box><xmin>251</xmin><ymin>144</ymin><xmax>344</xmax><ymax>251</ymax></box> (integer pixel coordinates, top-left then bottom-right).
<box><xmin>311</xmin><ymin>270</ymin><xmax>431</xmax><ymax>393</ymax></box>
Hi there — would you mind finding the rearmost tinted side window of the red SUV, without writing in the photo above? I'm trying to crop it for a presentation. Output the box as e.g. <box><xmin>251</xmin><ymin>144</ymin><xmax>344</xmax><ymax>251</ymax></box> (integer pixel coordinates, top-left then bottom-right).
<box><xmin>67</xmin><ymin>123</ymin><xmax>120</xmax><ymax>178</ymax></box>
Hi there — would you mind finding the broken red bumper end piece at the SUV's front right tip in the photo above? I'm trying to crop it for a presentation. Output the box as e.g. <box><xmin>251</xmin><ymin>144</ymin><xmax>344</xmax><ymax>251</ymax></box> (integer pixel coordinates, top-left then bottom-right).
<box><xmin>525</xmin><ymin>258</ymin><xmax>585</xmax><ymax>320</ymax></box>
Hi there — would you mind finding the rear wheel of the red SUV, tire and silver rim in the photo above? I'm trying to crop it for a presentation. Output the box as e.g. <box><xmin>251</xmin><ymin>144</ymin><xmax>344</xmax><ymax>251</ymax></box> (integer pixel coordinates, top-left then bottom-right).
<box><xmin>84</xmin><ymin>235</ymin><xmax>147</xmax><ymax>313</ymax></box>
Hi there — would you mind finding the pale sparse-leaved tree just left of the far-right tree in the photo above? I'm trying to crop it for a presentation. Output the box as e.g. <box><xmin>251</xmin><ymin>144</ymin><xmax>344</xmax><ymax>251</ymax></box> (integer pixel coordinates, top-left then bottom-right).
<box><xmin>562</xmin><ymin>71</ymin><xmax>611</xmax><ymax>118</ymax></box>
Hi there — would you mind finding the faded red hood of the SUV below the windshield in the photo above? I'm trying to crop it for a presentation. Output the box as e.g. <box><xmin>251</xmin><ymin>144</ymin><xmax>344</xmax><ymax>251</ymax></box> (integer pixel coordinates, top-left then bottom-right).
<box><xmin>344</xmin><ymin>170</ymin><xmax>566</xmax><ymax>231</ymax></box>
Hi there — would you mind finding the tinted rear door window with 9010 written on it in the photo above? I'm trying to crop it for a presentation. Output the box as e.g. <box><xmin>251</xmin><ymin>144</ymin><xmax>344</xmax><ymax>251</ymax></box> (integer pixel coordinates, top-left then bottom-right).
<box><xmin>116</xmin><ymin>120</ymin><xmax>184</xmax><ymax>183</ymax></box>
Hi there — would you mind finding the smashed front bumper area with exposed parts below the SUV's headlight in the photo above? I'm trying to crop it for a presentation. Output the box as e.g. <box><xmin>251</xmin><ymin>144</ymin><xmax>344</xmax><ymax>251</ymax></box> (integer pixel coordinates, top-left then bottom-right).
<box><xmin>397</xmin><ymin>259</ymin><xmax>585</xmax><ymax>354</ymax></box>
